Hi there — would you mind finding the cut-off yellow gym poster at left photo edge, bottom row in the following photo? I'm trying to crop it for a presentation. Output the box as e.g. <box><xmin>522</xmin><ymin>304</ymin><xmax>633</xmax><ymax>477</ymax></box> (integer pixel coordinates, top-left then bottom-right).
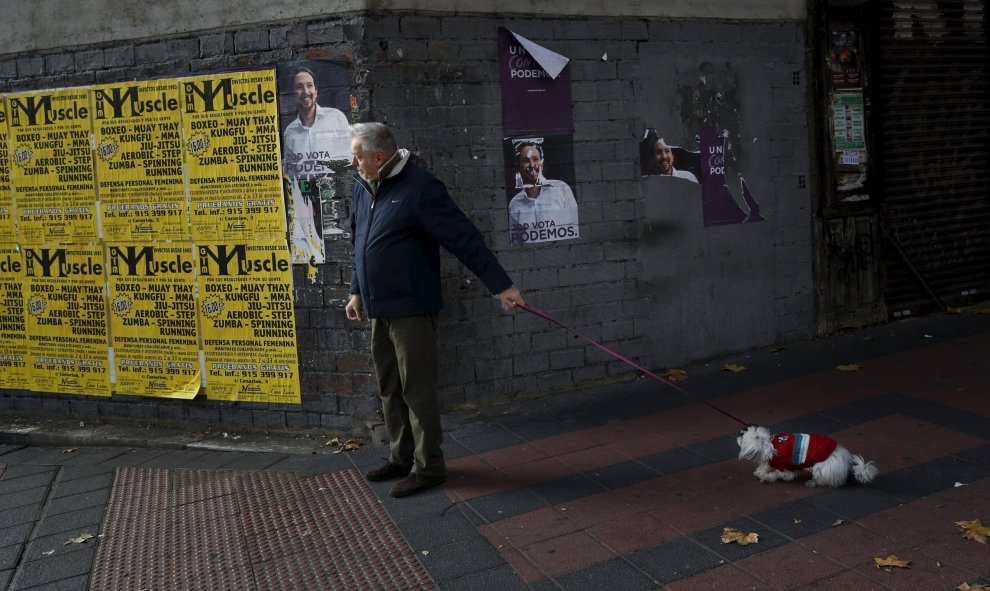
<box><xmin>0</xmin><ymin>244</ymin><xmax>31</xmax><ymax>390</ymax></box>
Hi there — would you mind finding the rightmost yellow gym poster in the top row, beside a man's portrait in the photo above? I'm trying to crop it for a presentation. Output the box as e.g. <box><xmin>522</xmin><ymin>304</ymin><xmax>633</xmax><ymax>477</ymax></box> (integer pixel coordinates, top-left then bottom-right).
<box><xmin>179</xmin><ymin>70</ymin><xmax>286</xmax><ymax>243</ymax></box>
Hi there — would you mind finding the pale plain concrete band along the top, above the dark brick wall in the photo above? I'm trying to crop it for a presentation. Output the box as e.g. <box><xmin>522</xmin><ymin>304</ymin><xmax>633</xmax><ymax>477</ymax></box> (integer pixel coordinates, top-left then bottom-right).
<box><xmin>0</xmin><ymin>0</ymin><xmax>805</xmax><ymax>55</ymax></box>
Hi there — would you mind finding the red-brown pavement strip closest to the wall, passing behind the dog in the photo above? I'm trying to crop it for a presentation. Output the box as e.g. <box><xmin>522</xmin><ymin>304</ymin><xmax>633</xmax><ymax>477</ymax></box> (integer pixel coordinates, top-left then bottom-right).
<box><xmin>445</xmin><ymin>335</ymin><xmax>990</xmax><ymax>501</ymax></box>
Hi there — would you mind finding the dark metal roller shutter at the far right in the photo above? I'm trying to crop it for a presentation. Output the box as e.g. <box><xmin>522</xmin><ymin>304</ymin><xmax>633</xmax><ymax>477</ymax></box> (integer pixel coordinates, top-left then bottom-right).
<box><xmin>872</xmin><ymin>0</ymin><xmax>990</xmax><ymax>317</ymax></box>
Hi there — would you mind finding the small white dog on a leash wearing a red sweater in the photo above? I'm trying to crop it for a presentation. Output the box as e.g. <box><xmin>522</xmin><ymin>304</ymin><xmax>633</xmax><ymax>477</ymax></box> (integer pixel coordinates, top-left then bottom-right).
<box><xmin>736</xmin><ymin>425</ymin><xmax>879</xmax><ymax>487</ymax></box>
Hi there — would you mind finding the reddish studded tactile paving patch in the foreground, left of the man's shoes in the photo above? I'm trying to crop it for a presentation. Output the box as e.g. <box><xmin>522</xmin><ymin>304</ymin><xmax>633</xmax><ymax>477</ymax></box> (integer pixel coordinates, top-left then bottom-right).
<box><xmin>90</xmin><ymin>468</ymin><xmax>434</xmax><ymax>591</ymax></box>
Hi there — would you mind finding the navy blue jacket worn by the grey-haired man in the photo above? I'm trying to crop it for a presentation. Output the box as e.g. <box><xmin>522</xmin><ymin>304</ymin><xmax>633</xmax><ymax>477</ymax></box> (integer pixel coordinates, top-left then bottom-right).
<box><xmin>350</xmin><ymin>154</ymin><xmax>512</xmax><ymax>318</ymax></box>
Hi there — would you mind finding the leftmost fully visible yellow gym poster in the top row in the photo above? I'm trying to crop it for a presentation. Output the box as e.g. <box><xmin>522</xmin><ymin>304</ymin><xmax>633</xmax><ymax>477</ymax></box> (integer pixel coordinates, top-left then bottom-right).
<box><xmin>7</xmin><ymin>87</ymin><xmax>99</xmax><ymax>244</ymax></box>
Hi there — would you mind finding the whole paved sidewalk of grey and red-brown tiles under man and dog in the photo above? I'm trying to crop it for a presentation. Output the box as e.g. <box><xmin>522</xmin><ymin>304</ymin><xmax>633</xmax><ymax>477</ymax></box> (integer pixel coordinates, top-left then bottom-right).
<box><xmin>0</xmin><ymin>313</ymin><xmax>990</xmax><ymax>591</ymax></box>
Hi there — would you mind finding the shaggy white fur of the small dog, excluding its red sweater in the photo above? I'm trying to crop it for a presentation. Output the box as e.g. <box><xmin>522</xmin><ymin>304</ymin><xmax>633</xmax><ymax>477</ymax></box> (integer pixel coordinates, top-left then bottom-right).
<box><xmin>736</xmin><ymin>425</ymin><xmax>879</xmax><ymax>488</ymax></box>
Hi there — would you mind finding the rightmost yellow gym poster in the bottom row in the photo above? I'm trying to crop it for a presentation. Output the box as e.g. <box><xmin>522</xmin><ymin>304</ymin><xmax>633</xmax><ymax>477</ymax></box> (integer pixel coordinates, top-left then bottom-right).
<box><xmin>196</xmin><ymin>240</ymin><xmax>300</xmax><ymax>404</ymax></box>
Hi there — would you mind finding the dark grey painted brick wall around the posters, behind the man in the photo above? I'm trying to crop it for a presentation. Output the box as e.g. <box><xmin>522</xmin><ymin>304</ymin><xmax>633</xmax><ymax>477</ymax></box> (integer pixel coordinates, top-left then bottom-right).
<box><xmin>0</xmin><ymin>9</ymin><xmax>814</xmax><ymax>430</ymax></box>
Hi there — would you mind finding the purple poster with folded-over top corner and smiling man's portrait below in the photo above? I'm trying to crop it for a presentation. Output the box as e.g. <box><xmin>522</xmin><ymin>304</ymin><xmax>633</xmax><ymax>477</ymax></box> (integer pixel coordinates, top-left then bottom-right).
<box><xmin>498</xmin><ymin>27</ymin><xmax>581</xmax><ymax>245</ymax></box>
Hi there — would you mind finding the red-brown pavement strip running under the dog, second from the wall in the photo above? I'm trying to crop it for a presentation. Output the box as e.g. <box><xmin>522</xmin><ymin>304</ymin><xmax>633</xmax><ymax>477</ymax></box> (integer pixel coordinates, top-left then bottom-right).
<box><xmin>468</xmin><ymin>415</ymin><xmax>984</xmax><ymax>584</ymax></box>
